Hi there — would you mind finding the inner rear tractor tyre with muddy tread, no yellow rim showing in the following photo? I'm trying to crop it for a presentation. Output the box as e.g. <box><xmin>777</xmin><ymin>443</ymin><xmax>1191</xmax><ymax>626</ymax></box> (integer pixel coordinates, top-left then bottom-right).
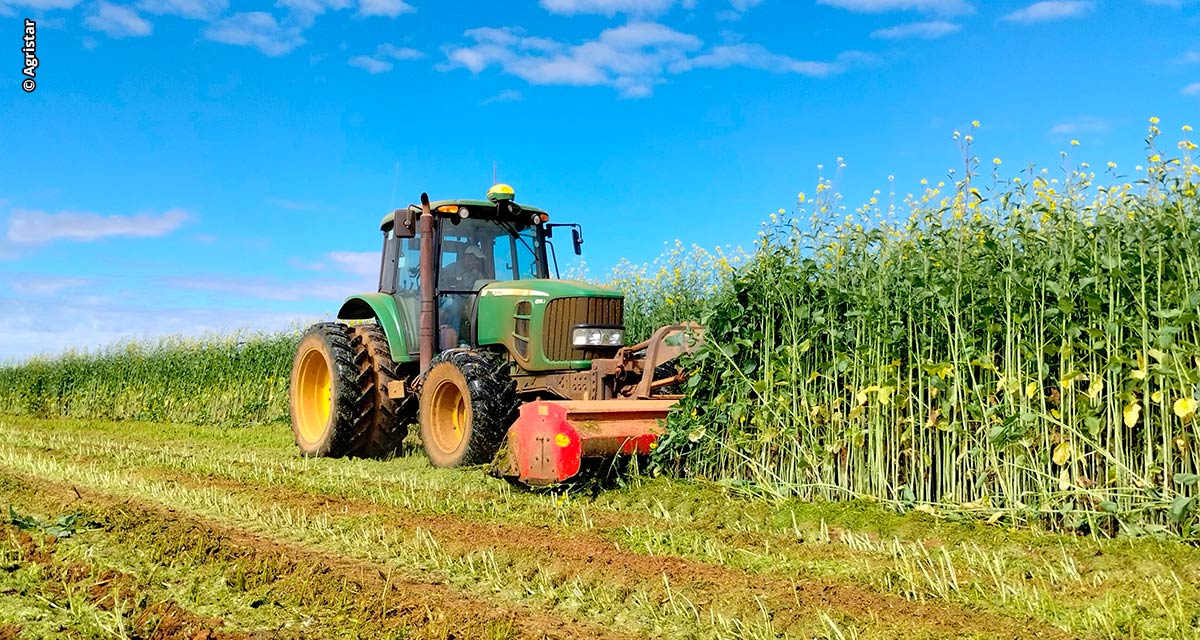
<box><xmin>350</xmin><ymin>324</ymin><xmax>416</xmax><ymax>457</ymax></box>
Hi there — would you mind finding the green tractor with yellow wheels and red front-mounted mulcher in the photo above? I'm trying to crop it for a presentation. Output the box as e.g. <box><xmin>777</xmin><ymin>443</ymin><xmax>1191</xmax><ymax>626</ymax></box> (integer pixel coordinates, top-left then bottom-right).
<box><xmin>289</xmin><ymin>184</ymin><xmax>703</xmax><ymax>486</ymax></box>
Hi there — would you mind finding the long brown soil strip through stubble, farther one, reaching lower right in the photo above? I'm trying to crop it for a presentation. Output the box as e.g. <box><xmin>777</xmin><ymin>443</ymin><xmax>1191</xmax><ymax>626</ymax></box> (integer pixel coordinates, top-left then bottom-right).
<box><xmin>140</xmin><ymin>467</ymin><xmax>1073</xmax><ymax>639</ymax></box>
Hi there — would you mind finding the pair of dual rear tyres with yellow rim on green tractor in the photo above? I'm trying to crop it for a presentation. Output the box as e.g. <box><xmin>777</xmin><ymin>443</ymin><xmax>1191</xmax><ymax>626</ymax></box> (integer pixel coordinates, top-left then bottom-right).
<box><xmin>288</xmin><ymin>322</ymin><xmax>406</xmax><ymax>457</ymax></box>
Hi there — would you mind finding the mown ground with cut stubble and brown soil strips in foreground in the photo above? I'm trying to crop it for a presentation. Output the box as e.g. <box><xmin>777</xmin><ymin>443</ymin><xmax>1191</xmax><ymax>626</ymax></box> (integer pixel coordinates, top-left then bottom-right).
<box><xmin>7</xmin><ymin>417</ymin><xmax>1200</xmax><ymax>639</ymax></box>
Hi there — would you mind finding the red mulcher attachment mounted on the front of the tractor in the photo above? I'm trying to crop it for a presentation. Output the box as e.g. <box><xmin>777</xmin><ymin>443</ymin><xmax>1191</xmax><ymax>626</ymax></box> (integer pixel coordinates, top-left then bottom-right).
<box><xmin>502</xmin><ymin>400</ymin><xmax>676</xmax><ymax>485</ymax></box>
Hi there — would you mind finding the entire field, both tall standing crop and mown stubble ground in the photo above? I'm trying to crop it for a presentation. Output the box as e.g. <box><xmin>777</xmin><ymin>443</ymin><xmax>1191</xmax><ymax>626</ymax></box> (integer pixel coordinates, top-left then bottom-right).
<box><xmin>0</xmin><ymin>119</ymin><xmax>1200</xmax><ymax>640</ymax></box>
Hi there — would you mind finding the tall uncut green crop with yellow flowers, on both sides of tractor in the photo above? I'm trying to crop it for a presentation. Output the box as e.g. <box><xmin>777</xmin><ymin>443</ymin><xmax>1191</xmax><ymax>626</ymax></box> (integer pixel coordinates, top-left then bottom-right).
<box><xmin>0</xmin><ymin>120</ymin><xmax>1200</xmax><ymax>538</ymax></box>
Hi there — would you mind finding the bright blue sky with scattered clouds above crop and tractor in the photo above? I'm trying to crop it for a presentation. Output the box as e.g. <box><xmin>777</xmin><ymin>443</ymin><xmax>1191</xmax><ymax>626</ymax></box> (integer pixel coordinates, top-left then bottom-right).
<box><xmin>0</xmin><ymin>0</ymin><xmax>1200</xmax><ymax>360</ymax></box>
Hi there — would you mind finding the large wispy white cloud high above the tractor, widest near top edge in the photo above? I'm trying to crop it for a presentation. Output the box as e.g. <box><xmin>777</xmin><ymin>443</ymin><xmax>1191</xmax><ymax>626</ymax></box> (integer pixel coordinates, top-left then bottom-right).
<box><xmin>442</xmin><ymin>22</ymin><xmax>853</xmax><ymax>97</ymax></box>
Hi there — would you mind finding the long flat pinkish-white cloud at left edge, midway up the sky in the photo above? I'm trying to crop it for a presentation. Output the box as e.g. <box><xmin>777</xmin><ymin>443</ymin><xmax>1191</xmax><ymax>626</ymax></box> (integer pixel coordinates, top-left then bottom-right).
<box><xmin>6</xmin><ymin>209</ymin><xmax>187</xmax><ymax>245</ymax></box>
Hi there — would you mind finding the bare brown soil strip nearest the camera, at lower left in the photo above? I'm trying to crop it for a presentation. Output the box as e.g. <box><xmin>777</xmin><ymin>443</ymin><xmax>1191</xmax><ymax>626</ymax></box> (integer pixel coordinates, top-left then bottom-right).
<box><xmin>4</xmin><ymin>471</ymin><xmax>630</xmax><ymax>640</ymax></box>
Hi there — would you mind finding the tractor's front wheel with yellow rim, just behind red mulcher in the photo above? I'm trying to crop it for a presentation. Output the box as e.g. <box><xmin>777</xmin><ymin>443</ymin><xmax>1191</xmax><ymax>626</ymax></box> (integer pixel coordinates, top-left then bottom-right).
<box><xmin>420</xmin><ymin>349</ymin><xmax>517</xmax><ymax>468</ymax></box>
